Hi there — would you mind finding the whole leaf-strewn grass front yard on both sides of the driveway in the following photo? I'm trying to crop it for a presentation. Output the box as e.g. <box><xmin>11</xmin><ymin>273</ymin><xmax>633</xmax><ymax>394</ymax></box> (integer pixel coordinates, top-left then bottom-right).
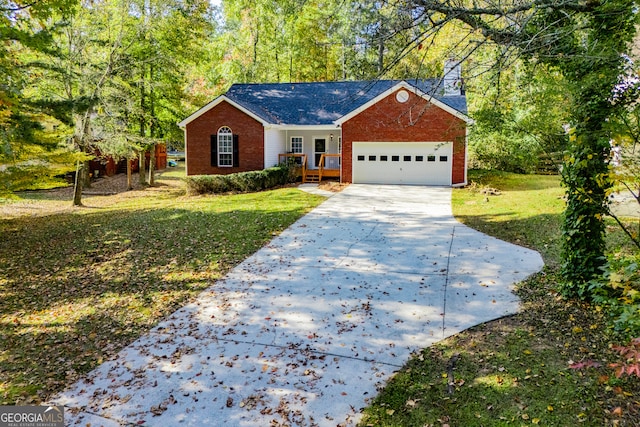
<box><xmin>0</xmin><ymin>170</ymin><xmax>640</xmax><ymax>427</ymax></box>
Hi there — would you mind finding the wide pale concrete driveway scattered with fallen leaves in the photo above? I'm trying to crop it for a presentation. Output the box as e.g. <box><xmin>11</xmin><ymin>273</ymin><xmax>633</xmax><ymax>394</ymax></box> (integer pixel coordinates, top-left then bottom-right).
<box><xmin>55</xmin><ymin>185</ymin><xmax>543</xmax><ymax>427</ymax></box>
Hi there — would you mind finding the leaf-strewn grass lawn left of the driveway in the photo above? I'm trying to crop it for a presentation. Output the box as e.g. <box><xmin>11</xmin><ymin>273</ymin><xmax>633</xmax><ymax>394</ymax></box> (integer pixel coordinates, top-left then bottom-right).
<box><xmin>0</xmin><ymin>170</ymin><xmax>323</xmax><ymax>405</ymax></box>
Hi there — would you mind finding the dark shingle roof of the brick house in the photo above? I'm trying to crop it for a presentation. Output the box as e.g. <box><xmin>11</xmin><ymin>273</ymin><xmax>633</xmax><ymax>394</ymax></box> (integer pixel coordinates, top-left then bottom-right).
<box><xmin>225</xmin><ymin>79</ymin><xmax>467</xmax><ymax>125</ymax></box>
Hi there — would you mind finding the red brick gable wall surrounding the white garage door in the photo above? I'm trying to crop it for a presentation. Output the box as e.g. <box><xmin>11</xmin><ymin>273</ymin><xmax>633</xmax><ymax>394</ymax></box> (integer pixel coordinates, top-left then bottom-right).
<box><xmin>342</xmin><ymin>93</ymin><xmax>466</xmax><ymax>184</ymax></box>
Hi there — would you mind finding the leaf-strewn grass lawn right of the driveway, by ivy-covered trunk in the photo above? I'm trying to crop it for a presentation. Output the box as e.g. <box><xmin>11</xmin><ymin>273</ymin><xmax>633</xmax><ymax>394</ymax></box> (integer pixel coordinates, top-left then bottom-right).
<box><xmin>361</xmin><ymin>172</ymin><xmax>640</xmax><ymax>427</ymax></box>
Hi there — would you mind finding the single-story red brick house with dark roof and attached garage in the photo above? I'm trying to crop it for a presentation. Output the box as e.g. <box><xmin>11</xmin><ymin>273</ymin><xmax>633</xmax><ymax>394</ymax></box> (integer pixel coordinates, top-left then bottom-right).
<box><xmin>179</xmin><ymin>61</ymin><xmax>473</xmax><ymax>186</ymax></box>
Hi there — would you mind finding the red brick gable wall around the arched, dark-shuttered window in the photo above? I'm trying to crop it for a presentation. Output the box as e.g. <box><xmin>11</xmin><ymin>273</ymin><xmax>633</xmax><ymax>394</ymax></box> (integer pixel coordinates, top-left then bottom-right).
<box><xmin>186</xmin><ymin>101</ymin><xmax>264</xmax><ymax>175</ymax></box>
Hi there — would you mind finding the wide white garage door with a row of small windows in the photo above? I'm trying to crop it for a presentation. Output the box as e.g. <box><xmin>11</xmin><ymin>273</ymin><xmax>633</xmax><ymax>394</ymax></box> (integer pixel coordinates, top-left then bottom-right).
<box><xmin>353</xmin><ymin>142</ymin><xmax>453</xmax><ymax>185</ymax></box>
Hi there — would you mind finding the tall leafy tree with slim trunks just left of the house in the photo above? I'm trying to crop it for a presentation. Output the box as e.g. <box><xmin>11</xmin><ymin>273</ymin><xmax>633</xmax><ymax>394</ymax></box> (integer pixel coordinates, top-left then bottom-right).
<box><xmin>97</xmin><ymin>0</ymin><xmax>211</xmax><ymax>184</ymax></box>
